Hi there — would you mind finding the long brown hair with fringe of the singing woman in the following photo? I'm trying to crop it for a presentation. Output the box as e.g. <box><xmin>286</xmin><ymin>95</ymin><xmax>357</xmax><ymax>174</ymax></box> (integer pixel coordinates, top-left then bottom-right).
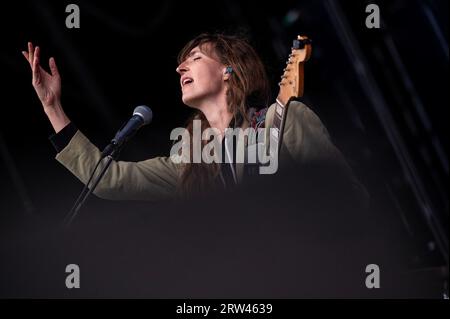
<box><xmin>178</xmin><ymin>33</ymin><xmax>269</xmax><ymax>196</ymax></box>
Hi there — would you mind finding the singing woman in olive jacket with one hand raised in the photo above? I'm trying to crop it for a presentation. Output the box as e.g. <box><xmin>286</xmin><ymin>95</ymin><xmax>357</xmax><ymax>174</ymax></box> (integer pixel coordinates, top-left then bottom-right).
<box><xmin>23</xmin><ymin>34</ymin><xmax>366</xmax><ymax>200</ymax></box>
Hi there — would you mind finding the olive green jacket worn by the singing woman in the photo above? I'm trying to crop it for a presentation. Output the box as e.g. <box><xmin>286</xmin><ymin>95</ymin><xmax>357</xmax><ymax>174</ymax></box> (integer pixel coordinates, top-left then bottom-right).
<box><xmin>56</xmin><ymin>102</ymin><xmax>363</xmax><ymax>200</ymax></box>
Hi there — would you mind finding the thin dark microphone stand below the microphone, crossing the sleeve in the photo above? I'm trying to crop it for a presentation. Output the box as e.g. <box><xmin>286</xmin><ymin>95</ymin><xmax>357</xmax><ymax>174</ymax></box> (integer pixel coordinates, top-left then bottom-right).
<box><xmin>63</xmin><ymin>143</ymin><xmax>125</xmax><ymax>227</ymax></box>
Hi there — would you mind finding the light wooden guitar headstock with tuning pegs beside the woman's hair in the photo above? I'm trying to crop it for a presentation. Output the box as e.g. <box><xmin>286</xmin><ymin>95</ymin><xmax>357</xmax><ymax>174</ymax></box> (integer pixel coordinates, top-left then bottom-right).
<box><xmin>277</xmin><ymin>35</ymin><xmax>312</xmax><ymax>105</ymax></box>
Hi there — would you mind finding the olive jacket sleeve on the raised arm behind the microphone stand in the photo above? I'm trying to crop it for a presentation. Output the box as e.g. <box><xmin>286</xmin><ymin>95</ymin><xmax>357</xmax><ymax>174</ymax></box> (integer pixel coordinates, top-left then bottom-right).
<box><xmin>56</xmin><ymin>130</ymin><xmax>179</xmax><ymax>200</ymax></box>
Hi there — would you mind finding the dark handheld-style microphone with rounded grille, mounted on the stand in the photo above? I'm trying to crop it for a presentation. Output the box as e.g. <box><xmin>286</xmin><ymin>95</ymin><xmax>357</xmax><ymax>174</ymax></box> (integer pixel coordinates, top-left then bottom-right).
<box><xmin>102</xmin><ymin>105</ymin><xmax>153</xmax><ymax>157</ymax></box>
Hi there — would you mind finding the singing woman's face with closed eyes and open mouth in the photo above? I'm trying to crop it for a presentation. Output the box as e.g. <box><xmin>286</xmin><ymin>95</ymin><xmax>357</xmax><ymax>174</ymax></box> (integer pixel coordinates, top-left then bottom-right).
<box><xmin>177</xmin><ymin>44</ymin><xmax>228</xmax><ymax>108</ymax></box>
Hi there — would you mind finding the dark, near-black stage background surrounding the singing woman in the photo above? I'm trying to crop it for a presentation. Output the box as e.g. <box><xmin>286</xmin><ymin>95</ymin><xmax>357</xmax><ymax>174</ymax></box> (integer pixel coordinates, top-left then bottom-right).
<box><xmin>0</xmin><ymin>0</ymin><xmax>448</xmax><ymax>298</ymax></box>
